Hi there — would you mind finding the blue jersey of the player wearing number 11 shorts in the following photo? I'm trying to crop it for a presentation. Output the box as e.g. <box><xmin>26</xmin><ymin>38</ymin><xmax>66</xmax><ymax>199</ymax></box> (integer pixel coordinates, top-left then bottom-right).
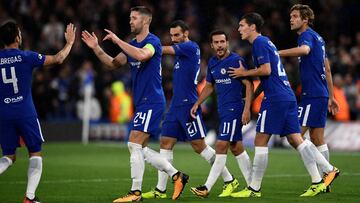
<box><xmin>206</xmin><ymin>52</ymin><xmax>246</xmax><ymax>112</ymax></box>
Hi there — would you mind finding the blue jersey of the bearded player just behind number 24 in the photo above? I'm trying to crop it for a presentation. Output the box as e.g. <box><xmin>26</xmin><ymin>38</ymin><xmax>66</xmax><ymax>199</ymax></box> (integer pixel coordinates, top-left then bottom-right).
<box><xmin>171</xmin><ymin>41</ymin><xmax>200</xmax><ymax>106</ymax></box>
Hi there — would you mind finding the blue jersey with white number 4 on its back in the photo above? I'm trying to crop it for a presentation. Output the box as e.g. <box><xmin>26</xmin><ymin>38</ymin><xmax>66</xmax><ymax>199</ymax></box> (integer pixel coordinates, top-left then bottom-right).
<box><xmin>0</xmin><ymin>49</ymin><xmax>47</xmax><ymax>120</ymax></box>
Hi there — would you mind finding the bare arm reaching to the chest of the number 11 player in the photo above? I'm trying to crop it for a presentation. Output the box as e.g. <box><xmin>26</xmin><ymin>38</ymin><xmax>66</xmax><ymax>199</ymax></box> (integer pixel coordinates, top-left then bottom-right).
<box><xmin>228</xmin><ymin>63</ymin><xmax>271</xmax><ymax>78</ymax></box>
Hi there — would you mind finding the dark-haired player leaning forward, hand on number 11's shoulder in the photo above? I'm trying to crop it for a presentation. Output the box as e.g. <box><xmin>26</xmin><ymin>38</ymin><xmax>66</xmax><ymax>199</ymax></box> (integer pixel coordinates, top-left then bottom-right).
<box><xmin>229</xmin><ymin>13</ymin><xmax>337</xmax><ymax>197</ymax></box>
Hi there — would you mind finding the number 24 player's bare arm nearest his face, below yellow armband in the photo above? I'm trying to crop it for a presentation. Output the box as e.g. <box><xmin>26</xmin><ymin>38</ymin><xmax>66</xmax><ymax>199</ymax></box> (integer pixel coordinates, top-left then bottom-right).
<box><xmin>103</xmin><ymin>29</ymin><xmax>155</xmax><ymax>62</ymax></box>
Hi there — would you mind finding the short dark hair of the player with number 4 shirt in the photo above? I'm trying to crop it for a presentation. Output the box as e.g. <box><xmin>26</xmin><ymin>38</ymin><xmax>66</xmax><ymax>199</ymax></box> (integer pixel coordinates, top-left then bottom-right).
<box><xmin>0</xmin><ymin>21</ymin><xmax>19</xmax><ymax>46</ymax></box>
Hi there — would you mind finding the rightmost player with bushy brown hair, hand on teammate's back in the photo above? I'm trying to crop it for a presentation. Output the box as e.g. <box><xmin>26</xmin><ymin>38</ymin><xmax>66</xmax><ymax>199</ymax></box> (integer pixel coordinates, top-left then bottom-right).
<box><xmin>279</xmin><ymin>4</ymin><xmax>339</xmax><ymax>192</ymax></box>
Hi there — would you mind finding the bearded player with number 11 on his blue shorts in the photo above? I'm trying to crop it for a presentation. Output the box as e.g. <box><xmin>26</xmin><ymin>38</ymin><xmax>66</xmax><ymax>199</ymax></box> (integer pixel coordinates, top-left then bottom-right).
<box><xmin>190</xmin><ymin>30</ymin><xmax>254</xmax><ymax>197</ymax></box>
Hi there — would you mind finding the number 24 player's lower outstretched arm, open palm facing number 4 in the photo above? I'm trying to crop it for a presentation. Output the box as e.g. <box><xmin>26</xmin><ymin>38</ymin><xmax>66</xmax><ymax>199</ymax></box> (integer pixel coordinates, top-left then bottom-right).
<box><xmin>81</xmin><ymin>30</ymin><xmax>127</xmax><ymax>69</ymax></box>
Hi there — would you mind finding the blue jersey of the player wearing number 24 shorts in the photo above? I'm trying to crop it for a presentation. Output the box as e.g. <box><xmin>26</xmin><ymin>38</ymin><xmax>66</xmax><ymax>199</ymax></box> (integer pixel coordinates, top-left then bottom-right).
<box><xmin>127</xmin><ymin>33</ymin><xmax>165</xmax><ymax>107</ymax></box>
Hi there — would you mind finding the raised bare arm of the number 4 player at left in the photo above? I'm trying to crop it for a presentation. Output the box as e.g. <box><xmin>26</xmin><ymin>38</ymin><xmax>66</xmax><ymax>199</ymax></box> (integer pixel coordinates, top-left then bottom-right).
<box><xmin>44</xmin><ymin>23</ymin><xmax>76</xmax><ymax>66</ymax></box>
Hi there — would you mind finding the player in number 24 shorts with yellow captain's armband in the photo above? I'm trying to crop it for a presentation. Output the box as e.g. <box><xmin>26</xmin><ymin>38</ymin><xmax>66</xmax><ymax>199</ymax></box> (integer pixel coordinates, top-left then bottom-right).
<box><xmin>82</xmin><ymin>6</ymin><xmax>189</xmax><ymax>202</ymax></box>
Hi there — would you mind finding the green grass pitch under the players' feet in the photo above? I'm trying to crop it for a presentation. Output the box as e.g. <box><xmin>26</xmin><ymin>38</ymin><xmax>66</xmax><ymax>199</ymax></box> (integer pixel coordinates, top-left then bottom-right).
<box><xmin>0</xmin><ymin>143</ymin><xmax>360</xmax><ymax>203</ymax></box>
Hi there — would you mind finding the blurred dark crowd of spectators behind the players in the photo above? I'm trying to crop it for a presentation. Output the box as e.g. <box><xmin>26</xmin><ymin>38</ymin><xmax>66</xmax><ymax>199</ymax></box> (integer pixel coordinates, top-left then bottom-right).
<box><xmin>0</xmin><ymin>0</ymin><xmax>360</xmax><ymax>122</ymax></box>
